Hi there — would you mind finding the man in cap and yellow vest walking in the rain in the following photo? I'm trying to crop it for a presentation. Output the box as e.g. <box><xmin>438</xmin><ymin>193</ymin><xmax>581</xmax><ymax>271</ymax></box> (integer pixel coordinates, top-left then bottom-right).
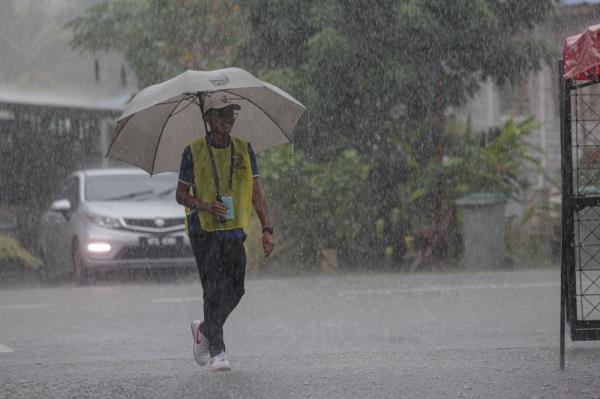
<box><xmin>176</xmin><ymin>93</ymin><xmax>274</xmax><ymax>371</ymax></box>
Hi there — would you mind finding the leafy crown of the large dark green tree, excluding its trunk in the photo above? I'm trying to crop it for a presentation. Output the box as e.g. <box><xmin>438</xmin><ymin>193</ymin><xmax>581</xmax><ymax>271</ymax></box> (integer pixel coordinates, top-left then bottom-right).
<box><xmin>238</xmin><ymin>0</ymin><xmax>552</xmax><ymax>155</ymax></box>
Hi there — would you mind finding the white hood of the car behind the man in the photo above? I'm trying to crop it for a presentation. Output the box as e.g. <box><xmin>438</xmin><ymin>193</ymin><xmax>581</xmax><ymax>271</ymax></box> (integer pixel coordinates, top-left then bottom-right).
<box><xmin>85</xmin><ymin>201</ymin><xmax>185</xmax><ymax>219</ymax></box>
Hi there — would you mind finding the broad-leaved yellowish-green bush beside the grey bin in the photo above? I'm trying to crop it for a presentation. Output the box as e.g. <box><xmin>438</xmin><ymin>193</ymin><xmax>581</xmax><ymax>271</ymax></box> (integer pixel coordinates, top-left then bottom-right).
<box><xmin>399</xmin><ymin>118</ymin><xmax>540</xmax><ymax>267</ymax></box>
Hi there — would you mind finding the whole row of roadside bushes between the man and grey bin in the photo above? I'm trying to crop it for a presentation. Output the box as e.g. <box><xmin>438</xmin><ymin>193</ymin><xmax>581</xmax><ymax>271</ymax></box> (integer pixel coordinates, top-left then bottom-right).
<box><xmin>251</xmin><ymin>119</ymin><xmax>539</xmax><ymax>269</ymax></box>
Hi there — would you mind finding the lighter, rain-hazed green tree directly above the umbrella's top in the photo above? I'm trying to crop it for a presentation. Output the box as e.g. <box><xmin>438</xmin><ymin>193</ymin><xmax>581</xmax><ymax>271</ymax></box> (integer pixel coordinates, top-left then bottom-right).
<box><xmin>66</xmin><ymin>0</ymin><xmax>243</xmax><ymax>87</ymax></box>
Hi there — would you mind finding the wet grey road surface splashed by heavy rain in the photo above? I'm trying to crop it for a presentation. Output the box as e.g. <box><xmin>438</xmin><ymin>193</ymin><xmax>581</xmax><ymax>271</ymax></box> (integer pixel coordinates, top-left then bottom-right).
<box><xmin>0</xmin><ymin>270</ymin><xmax>600</xmax><ymax>398</ymax></box>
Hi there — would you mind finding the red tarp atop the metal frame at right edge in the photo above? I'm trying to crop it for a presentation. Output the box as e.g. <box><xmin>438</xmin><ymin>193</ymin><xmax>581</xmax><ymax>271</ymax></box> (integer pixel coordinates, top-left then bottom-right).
<box><xmin>563</xmin><ymin>25</ymin><xmax>600</xmax><ymax>80</ymax></box>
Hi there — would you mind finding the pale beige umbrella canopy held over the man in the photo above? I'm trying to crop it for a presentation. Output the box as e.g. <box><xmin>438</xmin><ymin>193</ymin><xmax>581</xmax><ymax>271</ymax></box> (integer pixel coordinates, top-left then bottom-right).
<box><xmin>106</xmin><ymin>68</ymin><xmax>306</xmax><ymax>174</ymax></box>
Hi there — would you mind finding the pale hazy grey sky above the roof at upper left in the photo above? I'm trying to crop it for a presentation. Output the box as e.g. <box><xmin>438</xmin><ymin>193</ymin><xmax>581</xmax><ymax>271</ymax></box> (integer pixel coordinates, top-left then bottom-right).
<box><xmin>0</xmin><ymin>0</ymin><xmax>135</xmax><ymax>98</ymax></box>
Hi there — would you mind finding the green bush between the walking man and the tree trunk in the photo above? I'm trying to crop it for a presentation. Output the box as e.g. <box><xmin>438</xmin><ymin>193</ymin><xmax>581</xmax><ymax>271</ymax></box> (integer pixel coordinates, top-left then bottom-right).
<box><xmin>258</xmin><ymin>146</ymin><xmax>373</xmax><ymax>267</ymax></box>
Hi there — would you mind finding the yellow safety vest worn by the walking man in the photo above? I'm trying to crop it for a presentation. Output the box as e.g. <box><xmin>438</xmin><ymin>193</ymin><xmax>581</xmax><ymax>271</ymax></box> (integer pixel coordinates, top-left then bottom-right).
<box><xmin>186</xmin><ymin>137</ymin><xmax>254</xmax><ymax>231</ymax></box>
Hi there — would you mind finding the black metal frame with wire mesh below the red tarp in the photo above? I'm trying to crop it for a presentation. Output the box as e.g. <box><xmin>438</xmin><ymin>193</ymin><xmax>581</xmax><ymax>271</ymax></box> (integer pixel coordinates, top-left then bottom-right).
<box><xmin>559</xmin><ymin>60</ymin><xmax>600</xmax><ymax>369</ymax></box>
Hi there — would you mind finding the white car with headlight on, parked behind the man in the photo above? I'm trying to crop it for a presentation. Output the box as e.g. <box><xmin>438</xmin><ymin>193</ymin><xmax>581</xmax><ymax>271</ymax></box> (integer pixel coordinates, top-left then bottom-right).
<box><xmin>40</xmin><ymin>168</ymin><xmax>196</xmax><ymax>282</ymax></box>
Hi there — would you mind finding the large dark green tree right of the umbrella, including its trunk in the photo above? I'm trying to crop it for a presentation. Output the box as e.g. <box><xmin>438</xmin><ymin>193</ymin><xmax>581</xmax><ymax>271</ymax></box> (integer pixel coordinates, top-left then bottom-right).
<box><xmin>238</xmin><ymin>0</ymin><xmax>552</xmax><ymax>266</ymax></box>
